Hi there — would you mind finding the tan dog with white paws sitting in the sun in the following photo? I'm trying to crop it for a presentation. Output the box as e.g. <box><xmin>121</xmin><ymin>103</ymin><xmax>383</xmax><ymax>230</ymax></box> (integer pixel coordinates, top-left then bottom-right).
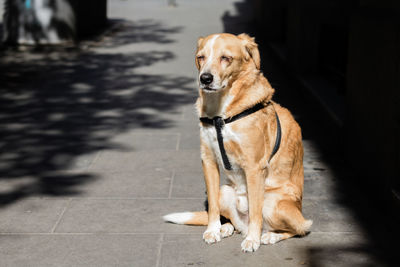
<box><xmin>164</xmin><ymin>33</ymin><xmax>312</xmax><ymax>251</ymax></box>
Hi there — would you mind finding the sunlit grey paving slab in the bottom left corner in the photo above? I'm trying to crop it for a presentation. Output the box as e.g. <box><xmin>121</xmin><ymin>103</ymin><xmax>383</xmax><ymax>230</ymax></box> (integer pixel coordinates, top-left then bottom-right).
<box><xmin>0</xmin><ymin>234</ymin><xmax>161</xmax><ymax>267</ymax></box>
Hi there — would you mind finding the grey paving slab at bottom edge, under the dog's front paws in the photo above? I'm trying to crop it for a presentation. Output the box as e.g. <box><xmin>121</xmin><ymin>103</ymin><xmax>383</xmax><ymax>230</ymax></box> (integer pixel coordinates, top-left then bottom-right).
<box><xmin>161</xmin><ymin>233</ymin><xmax>379</xmax><ymax>267</ymax></box>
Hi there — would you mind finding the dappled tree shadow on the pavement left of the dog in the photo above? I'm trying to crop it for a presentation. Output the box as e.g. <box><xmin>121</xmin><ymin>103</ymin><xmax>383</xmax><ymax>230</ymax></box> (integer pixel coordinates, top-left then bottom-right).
<box><xmin>0</xmin><ymin>18</ymin><xmax>193</xmax><ymax>206</ymax></box>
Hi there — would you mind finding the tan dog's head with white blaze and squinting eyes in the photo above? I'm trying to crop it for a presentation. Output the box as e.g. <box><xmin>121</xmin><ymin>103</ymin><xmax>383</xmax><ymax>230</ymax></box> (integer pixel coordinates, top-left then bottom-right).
<box><xmin>196</xmin><ymin>33</ymin><xmax>260</xmax><ymax>93</ymax></box>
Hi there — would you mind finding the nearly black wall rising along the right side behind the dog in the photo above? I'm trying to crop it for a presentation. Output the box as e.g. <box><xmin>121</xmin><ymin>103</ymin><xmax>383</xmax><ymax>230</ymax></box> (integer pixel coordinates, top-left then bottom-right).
<box><xmin>253</xmin><ymin>0</ymin><xmax>400</xmax><ymax>201</ymax></box>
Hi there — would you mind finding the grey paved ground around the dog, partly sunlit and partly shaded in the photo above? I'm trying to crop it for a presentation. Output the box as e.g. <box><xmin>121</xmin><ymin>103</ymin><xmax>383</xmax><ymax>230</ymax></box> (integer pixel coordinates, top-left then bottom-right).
<box><xmin>0</xmin><ymin>0</ymin><xmax>394</xmax><ymax>266</ymax></box>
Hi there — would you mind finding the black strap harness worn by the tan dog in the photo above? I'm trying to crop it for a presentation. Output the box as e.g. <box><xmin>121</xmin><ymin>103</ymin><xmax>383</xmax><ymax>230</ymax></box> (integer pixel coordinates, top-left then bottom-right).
<box><xmin>200</xmin><ymin>103</ymin><xmax>282</xmax><ymax>170</ymax></box>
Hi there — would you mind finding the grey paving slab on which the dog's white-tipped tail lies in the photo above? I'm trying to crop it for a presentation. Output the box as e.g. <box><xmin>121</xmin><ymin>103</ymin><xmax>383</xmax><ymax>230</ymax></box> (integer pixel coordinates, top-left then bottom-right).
<box><xmin>56</xmin><ymin>199</ymin><xmax>205</xmax><ymax>233</ymax></box>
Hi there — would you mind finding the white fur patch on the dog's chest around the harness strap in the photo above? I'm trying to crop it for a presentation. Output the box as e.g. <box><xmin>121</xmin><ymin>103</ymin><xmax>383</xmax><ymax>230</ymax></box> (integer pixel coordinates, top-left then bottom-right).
<box><xmin>200</xmin><ymin>124</ymin><xmax>246</xmax><ymax>193</ymax></box>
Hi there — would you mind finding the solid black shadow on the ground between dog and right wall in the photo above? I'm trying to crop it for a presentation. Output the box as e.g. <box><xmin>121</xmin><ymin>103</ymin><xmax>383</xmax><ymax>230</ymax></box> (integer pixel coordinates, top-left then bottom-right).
<box><xmin>222</xmin><ymin>0</ymin><xmax>399</xmax><ymax>266</ymax></box>
